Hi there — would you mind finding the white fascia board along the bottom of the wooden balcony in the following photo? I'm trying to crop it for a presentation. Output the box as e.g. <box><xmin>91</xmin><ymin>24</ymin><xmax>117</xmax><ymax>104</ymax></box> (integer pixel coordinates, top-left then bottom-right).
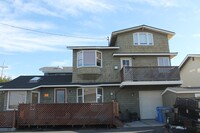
<box><xmin>120</xmin><ymin>80</ymin><xmax>182</xmax><ymax>87</ymax></box>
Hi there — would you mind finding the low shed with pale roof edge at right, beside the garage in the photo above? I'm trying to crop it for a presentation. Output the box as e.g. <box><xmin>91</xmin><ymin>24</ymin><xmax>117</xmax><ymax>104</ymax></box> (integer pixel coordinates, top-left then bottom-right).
<box><xmin>161</xmin><ymin>87</ymin><xmax>200</xmax><ymax>107</ymax></box>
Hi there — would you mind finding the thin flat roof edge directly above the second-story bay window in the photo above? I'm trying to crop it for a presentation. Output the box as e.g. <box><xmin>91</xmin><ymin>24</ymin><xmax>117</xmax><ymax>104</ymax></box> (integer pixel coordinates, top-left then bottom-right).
<box><xmin>67</xmin><ymin>46</ymin><xmax>119</xmax><ymax>50</ymax></box>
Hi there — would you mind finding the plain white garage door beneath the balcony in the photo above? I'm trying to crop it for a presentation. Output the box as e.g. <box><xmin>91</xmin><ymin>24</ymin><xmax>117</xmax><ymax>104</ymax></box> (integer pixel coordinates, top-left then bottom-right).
<box><xmin>139</xmin><ymin>91</ymin><xmax>162</xmax><ymax>119</ymax></box>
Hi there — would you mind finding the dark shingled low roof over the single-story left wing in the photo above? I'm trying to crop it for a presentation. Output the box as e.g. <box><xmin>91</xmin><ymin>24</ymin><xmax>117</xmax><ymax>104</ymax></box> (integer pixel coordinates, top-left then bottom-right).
<box><xmin>0</xmin><ymin>74</ymin><xmax>120</xmax><ymax>91</ymax></box>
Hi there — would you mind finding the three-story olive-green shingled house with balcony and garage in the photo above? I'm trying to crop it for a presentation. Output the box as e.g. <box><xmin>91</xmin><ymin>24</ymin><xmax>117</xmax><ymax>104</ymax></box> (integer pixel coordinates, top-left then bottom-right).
<box><xmin>0</xmin><ymin>25</ymin><xmax>181</xmax><ymax>119</ymax></box>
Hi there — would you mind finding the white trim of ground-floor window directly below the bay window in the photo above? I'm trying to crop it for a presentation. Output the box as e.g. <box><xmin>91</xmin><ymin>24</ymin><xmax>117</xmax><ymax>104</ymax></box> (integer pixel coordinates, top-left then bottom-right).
<box><xmin>76</xmin><ymin>87</ymin><xmax>104</xmax><ymax>103</ymax></box>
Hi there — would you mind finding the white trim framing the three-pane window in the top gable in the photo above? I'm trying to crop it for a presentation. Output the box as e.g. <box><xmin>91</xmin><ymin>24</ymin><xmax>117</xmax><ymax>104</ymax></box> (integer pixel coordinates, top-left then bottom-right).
<box><xmin>133</xmin><ymin>32</ymin><xmax>154</xmax><ymax>46</ymax></box>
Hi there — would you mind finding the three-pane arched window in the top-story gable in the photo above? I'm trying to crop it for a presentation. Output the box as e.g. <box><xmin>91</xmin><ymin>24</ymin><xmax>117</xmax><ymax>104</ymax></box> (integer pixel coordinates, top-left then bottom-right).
<box><xmin>133</xmin><ymin>32</ymin><xmax>153</xmax><ymax>45</ymax></box>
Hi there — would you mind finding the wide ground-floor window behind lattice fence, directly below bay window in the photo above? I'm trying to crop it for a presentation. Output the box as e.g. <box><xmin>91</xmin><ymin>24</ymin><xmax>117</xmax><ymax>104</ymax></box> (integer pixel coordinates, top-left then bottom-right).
<box><xmin>77</xmin><ymin>88</ymin><xmax>103</xmax><ymax>103</ymax></box>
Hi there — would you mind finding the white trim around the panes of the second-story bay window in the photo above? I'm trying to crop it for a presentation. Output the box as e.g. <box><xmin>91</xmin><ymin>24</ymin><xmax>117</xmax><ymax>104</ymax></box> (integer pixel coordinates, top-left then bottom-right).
<box><xmin>76</xmin><ymin>50</ymin><xmax>103</xmax><ymax>68</ymax></box>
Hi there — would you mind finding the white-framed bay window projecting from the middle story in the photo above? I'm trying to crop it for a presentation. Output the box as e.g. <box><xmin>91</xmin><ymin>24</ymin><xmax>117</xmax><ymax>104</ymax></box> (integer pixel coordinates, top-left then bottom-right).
<box><xmin>77</xmin><ymin>50</ymin><xmax>102</xmax><ymax>67</ymax></box>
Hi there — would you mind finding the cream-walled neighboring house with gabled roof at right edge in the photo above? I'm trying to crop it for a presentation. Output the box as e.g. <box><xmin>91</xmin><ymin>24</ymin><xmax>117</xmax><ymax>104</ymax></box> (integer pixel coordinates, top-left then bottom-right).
<box><xmin>179</xmin><ymin>54</ymin><xmax>200</xmax><ymax>87</ymax></box>
